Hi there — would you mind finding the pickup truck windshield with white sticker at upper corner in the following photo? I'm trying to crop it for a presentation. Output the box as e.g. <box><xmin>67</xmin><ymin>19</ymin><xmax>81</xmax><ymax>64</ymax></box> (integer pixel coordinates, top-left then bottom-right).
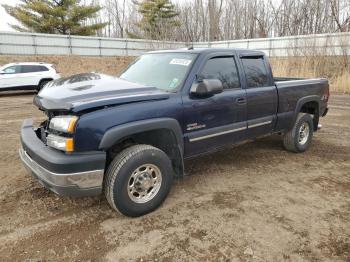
<box><xmin>120</xmin><ymin>53</ymin><xmax>196</xmax><ymax>91</ymax></box>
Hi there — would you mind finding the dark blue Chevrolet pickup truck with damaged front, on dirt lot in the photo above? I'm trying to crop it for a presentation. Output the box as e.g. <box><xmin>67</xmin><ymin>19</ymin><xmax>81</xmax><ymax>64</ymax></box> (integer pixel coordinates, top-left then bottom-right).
<box><xmin>19</xmin><ymin>49</ymin><xmax>329</xmax><ymax>216</ymax></box>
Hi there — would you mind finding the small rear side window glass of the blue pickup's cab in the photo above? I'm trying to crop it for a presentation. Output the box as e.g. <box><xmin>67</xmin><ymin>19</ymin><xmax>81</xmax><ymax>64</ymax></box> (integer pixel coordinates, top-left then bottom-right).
<box><xmin>242</xmin><ymin>57</ymin><xmax>269</xmax><ymax>88</ymax></box>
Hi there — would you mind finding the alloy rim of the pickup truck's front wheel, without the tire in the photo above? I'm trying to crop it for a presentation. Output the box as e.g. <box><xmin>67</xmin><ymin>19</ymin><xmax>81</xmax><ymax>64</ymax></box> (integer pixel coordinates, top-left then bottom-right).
<box><xmin>128</xmin><ymin>164</ymin><xmax>162</xmax><ymax>203</ymax></box>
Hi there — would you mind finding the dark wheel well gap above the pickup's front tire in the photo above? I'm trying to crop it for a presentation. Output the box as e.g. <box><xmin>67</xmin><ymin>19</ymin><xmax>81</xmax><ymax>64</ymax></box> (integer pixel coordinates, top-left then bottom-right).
<box><xmin>106</xmin><ymin>129</ymin><xmax>184</xmax><ymax>177</ymax></box>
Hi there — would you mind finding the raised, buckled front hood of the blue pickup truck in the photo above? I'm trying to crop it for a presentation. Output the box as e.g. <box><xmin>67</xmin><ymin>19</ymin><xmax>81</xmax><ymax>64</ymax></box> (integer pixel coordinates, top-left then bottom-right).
<box><xmin>34</xmin><ymin>73</ymin><xmax>169</xmax><ymax>112</ymax></box>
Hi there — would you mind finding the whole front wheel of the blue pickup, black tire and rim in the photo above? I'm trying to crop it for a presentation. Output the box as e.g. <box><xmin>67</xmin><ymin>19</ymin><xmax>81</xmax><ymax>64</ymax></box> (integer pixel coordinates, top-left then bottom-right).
<box><xmin>104</xmin><ymin>145</ymin><xmax>173</xmax><ymax>217</ymax></box>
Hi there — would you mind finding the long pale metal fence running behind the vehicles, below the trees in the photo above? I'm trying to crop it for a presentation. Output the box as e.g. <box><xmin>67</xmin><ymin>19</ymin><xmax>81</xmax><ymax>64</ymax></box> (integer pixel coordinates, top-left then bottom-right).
<box><xmin>0</xmin><ymin>31</ymin><xmax>350</xmax><ymax>57</ymax></box>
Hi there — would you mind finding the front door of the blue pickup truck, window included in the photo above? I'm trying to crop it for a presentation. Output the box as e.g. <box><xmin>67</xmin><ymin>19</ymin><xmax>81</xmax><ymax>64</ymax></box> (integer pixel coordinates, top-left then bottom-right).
<box><xmin>183</xmin><ymin>54</ymin><xmax>247</xmax><ymax>156</ymax></box>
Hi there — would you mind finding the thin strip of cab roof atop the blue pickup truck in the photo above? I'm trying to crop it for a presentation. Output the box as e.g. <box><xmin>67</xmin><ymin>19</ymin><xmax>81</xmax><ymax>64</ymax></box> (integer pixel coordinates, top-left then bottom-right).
<box><xmin>149</xmin><ymin>48</ymin><xmax>265</xmax><ymax>56</ymax></box>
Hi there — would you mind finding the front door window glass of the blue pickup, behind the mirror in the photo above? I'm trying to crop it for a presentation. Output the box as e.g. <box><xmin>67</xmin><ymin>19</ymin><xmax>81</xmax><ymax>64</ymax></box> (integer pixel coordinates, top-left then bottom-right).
<box><xmin>200</xmin><ymin>57</ymin><xmax>240</xmax><ymax>89</ymax></box>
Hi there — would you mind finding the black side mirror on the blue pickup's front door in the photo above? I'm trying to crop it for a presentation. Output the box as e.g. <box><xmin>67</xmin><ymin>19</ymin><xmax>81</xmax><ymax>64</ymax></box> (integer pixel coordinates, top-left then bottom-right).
<box><xmin>190</xmin><ymin>79</ymin><xmax>224</xmax><ymax>96</ymax></box>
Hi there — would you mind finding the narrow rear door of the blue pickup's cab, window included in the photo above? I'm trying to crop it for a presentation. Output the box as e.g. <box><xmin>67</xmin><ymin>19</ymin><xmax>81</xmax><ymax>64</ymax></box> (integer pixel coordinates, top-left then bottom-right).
<box><xmin>240</xmin><ymin>55</ymin><xmax>278</xmax><ymax>138</ymax></box>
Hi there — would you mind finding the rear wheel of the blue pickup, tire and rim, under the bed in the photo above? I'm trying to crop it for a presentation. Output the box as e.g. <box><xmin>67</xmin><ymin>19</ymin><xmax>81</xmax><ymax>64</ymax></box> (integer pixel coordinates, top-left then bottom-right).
<box><xmin>283</xmin><ymin>113</ymin><xmax>314</xmax><ymax>153</ymax></box>
